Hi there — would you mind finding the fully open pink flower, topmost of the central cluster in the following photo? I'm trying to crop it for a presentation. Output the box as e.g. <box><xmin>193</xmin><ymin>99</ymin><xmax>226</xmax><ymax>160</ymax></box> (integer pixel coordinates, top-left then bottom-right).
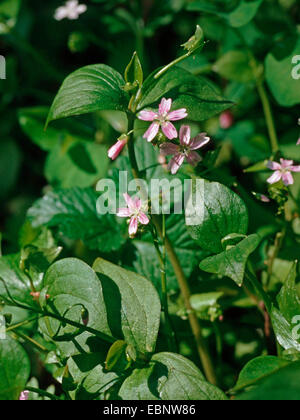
<box><xmin>138</xmin><ymin>98</ymin><xmax>188</xmax><ymax>142</ymax></box>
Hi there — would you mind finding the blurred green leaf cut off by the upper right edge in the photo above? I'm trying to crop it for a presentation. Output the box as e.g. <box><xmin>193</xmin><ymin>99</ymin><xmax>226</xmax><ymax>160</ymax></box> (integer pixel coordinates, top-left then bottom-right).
<box><xmin>265</xmin><ymin>36</ymin><xmax>300</xmax><ymax>107</ymax></box>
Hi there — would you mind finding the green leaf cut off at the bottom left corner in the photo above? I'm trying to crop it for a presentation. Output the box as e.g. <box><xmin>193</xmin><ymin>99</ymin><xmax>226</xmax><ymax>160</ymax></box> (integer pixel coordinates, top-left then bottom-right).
<box><xmin>0</xmin><ymin>337</ymin><xmax>30</xmax><ymax>401</ymax></box>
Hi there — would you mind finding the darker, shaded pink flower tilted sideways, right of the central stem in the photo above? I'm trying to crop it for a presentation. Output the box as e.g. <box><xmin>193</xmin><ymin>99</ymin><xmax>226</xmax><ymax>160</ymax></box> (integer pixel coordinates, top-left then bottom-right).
<box><xmin>161</xmin><ymin>125</ymin><xmax>210</xmax><ymax>175</ymax></box>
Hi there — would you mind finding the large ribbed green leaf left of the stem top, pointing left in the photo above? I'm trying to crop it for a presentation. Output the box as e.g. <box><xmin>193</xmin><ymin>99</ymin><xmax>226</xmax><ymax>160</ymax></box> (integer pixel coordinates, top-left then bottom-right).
<box><xmin>47</xmin><ymin>64</ymin><xmax>128</xmax><ymax>125</ymax></box>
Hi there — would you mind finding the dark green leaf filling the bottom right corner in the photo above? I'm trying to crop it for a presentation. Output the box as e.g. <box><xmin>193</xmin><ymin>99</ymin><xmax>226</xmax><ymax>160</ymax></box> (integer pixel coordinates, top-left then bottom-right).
<box><xmin>236</xmin><ymin>362</ymin><xmax>300</xmax><ymax>401</ymax></box>
